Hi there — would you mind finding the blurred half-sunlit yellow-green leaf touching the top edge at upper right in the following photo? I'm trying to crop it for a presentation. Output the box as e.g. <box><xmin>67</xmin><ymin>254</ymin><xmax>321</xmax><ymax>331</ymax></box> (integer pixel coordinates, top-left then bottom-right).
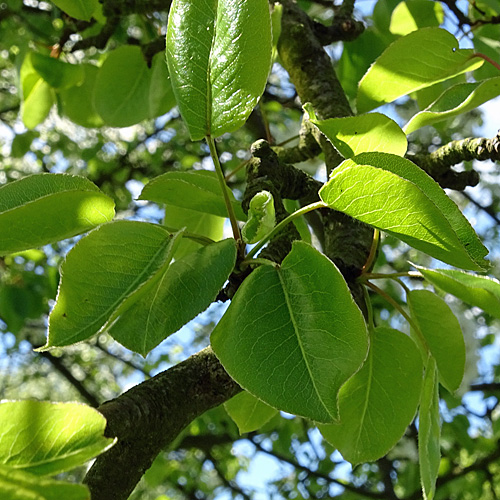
<box><xmin>389</xmin><ymin>0</ymin><xmax>444</xmax><ymax>35</ymax></box>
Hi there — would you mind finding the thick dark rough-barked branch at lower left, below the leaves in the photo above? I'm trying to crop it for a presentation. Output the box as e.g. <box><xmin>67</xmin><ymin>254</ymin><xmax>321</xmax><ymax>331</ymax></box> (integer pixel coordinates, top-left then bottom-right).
<box><xmin>84</xmin><ymin>347</ymin><xmax>241</xmax><ymax>500</ymax></box>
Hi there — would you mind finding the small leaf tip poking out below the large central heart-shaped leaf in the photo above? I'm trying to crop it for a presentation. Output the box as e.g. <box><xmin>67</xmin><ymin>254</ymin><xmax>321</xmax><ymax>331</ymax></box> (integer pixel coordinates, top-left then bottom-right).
<box><xmin>224</xmin><ymin>391</ymin><xmax>278</xmax><ymax>434</ymax></box>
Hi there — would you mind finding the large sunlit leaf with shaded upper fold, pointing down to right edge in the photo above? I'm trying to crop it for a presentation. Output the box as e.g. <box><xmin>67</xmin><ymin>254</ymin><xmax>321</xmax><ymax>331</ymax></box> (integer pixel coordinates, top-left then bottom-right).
<box><xmin>319</xmin><ymin>153</ymin><xmax>488</xmax><ymax>270</ymax></box>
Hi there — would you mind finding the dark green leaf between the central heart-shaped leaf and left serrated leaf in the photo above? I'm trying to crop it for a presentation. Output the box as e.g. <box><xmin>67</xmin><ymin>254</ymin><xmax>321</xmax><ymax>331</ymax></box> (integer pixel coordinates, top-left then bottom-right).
<box><xmin>109</xmin><ymin>239</ymin><xmax>236</xmax><ymax>356</ymax></box>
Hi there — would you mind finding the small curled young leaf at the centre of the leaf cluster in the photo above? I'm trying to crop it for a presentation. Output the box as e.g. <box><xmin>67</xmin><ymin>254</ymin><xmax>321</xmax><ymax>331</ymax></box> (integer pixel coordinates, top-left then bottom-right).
<box><xmin>241</xmin><ymin>191</ymin><xmax>276</xmax><ymax>244</ymax></box>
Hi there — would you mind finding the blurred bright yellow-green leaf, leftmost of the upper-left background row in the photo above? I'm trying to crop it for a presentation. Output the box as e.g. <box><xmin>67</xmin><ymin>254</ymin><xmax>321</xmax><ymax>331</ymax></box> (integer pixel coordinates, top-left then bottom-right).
<box><xmin>20</xmin><ymin>53</ymin><xmax>55</xmax><ymax>129</ymax></box>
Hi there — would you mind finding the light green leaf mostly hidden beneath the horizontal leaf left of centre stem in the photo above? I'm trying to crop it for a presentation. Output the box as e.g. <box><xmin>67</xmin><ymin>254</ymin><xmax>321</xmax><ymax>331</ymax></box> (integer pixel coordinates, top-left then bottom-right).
<box><xmin>163</xmin><ymin>205</ymin><xmax>225</xmax><ymax>259</ymax></box>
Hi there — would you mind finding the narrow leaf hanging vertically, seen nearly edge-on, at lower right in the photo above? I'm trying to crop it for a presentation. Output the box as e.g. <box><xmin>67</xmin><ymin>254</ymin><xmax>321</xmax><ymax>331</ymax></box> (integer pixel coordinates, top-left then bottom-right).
<box><xmin>418</xmin><ymin>357</ymin><xmax>441</xmax><ymax>500</ymax></box>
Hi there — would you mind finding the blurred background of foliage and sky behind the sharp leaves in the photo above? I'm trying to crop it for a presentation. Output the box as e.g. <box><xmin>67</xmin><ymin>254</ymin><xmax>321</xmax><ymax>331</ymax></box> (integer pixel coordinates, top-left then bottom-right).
<box><xmin>0</xmin><ymin>0</ymin><xmax>500</xmax><ymax>500</ymax></box>
